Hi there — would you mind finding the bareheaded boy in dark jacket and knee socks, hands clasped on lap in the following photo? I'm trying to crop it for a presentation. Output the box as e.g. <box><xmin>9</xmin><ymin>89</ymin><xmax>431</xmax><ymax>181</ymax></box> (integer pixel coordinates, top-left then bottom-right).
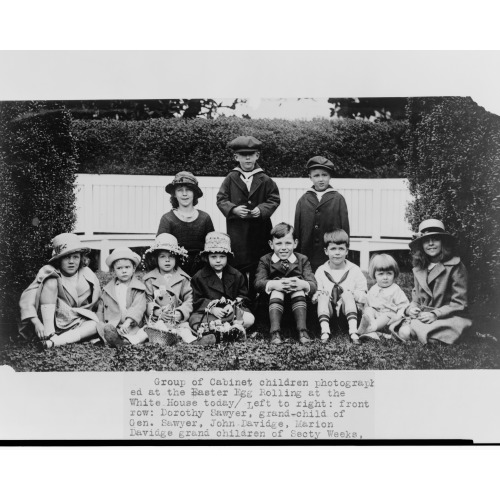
<box><xmin>255</xmin><ymin>222</ymin><xmax>316</xmax><ymax>344</ymax></box>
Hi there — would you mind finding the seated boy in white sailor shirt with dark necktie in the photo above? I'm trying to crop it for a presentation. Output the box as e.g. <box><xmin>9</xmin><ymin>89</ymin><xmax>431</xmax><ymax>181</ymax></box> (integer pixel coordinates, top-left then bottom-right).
<box><xmin>313</xmin><ymin>229</ymin><xmax>367</xmax><ymax>344</ymax></box>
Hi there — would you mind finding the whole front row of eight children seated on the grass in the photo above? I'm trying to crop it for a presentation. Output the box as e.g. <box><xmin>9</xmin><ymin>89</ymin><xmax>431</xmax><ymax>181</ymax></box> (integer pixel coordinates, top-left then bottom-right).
<box><xmin>20</xmin><ymin>220</ymin><xmax>470</xmax><ymax>348</ymax></box>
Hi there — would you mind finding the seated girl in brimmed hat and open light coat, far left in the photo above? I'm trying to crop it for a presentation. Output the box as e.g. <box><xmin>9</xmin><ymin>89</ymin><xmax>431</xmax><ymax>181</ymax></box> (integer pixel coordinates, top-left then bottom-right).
<box><xmin>19</xmin><ymin>233</ymin><xmax>101</xmax><ymax>348</ymax></box>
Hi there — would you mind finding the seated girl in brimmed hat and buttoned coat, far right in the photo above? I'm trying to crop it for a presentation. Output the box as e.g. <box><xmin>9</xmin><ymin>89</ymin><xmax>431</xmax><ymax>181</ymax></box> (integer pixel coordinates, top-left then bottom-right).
<box><xmin>394</xmin><ymin>219</ymin><xmax>472</xmax><ymax>344</ymax></box>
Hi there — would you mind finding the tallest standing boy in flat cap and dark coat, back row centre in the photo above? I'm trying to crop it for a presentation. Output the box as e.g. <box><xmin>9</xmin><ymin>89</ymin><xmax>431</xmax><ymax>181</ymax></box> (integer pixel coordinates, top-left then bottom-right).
<box><xmin>217</xmin><ymin>136</ymin><xmax>280</xmax><ymax>299</ymax></box>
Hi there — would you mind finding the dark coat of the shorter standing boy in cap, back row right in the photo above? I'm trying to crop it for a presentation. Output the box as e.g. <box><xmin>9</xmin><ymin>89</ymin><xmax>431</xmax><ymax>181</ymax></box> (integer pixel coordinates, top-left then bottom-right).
<box><xmin>294</xmin><ymin>191</ymin><xmax>350</xmax><ymax>271</ymax></box>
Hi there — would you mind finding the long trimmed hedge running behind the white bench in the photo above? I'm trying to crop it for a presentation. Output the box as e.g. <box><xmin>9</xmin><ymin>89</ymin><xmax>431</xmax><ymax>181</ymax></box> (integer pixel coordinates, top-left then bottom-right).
<box><xmin>72</xmin><ymin>118</ymin><xmax>407</xmax><ymax>177</ymax></box>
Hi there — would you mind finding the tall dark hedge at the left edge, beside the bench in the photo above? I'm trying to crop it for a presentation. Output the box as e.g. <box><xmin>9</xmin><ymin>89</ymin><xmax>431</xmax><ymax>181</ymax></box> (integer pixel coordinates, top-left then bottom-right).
<box><xmin>0</xmin><ymin>101</ymin><xmax>76</xmax><ymax>336</ymax></box>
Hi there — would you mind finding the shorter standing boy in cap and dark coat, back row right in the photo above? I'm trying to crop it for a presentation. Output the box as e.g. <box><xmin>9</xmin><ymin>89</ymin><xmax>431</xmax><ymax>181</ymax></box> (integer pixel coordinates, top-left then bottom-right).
<box><xmin>295</xmin><ymin>156</ymin><xmax>350</xmax><ymax>271</ymax></box>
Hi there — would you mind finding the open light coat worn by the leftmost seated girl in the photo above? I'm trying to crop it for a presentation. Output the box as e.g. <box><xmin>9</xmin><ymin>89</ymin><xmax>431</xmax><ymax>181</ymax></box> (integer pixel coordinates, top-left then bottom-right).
<box><xmin>19</xmin><ymin>264</ymin><xmax>101</xmax><ymax>339</ymax></box>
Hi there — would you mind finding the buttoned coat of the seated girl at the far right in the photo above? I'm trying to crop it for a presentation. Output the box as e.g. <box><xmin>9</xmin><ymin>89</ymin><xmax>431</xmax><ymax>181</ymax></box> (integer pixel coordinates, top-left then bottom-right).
<box><xmin>410</xmin><ymin>256</ymin><xmax>472</xmax><ymax>344</ymax></box>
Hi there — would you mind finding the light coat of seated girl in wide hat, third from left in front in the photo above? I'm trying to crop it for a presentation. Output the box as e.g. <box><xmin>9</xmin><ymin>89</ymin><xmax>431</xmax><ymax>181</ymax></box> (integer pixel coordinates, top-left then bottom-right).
<box><xmin>143</xmin><ymin>267</ymin><xmax>193</xmax><ymax>321</ymax></box>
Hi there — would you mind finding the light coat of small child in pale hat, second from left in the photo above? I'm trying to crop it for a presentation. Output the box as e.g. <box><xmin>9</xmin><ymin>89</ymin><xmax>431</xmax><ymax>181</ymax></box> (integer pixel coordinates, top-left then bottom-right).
<box><xmin>97</xmin><ymin>276</ymin><xmax>146</xmax><ymax>335</ymax></box>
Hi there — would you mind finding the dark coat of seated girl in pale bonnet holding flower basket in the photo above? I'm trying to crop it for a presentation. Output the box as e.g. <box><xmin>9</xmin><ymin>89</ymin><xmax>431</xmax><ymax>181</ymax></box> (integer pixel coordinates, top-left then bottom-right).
<box><xmin>189</xmin><ymin>265</ymin><xmax>249</xmax><ymax>328</ymax></box>
